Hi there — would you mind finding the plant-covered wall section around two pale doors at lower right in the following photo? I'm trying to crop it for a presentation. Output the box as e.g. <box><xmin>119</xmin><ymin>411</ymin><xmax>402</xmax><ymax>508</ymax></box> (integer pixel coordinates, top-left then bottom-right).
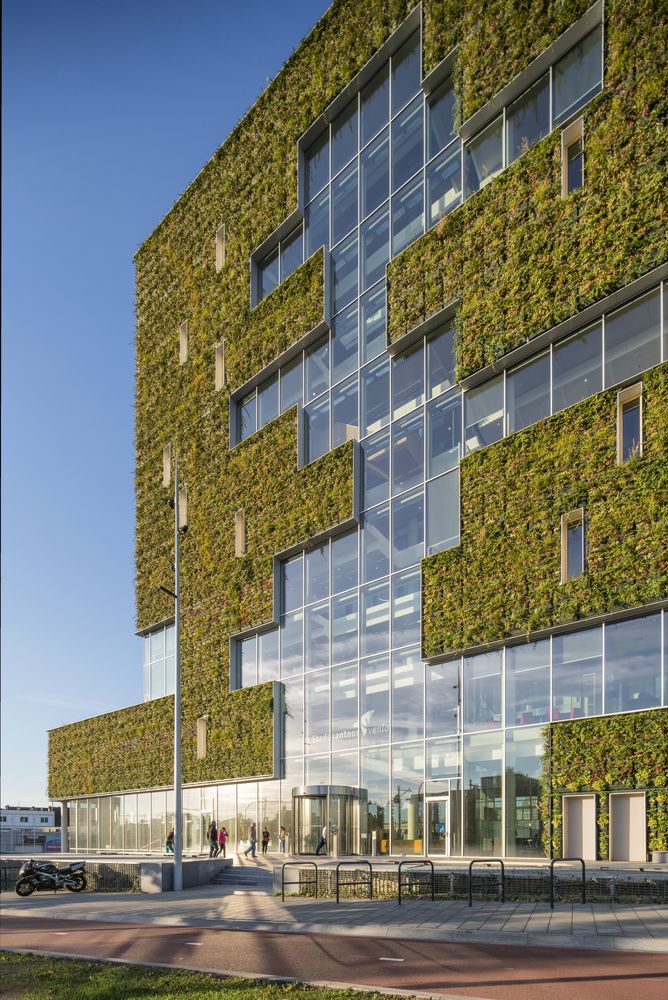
<box><xmin>541</xmin><ymin>708</ymin><xmax>668</xmax><ymax>861</ymax></box>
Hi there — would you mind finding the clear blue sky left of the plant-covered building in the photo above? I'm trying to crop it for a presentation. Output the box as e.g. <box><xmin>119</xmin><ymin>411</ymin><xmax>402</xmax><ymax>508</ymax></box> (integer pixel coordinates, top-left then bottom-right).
<box><xmin>0</xmin><ymin>0</ymin><xmax>328</xmax><ymax>805</ymax></box>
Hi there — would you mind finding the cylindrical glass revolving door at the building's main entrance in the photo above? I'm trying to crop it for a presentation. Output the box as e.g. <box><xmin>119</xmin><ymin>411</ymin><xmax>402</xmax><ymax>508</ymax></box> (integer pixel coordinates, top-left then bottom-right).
<box><xmin>292</xmin><ymin>785</ymin><xmax>367</xmax><ymax>857</ymax></box>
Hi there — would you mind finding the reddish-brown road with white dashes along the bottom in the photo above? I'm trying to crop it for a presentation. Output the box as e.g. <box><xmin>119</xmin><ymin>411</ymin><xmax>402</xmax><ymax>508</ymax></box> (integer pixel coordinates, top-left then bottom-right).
<box><xmin>0</xmin><ymin>916</ymin><xmax>668</xmax><ymax>1000</ymax></box>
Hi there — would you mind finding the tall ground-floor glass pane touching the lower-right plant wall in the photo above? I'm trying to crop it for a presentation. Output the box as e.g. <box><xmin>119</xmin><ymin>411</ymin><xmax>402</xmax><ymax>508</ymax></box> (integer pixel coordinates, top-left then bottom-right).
<box><xmin>506</xmin><ymin>729</ymin><xmax>545</xmax><ymax>858</ymax></box>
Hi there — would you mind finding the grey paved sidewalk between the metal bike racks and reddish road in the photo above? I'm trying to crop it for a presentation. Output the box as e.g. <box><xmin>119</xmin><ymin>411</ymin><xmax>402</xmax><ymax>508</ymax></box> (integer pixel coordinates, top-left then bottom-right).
<box><xmin>0</xmin><ymin>886</ymin><xmax>668</xmax><ymax>953</ymax></box>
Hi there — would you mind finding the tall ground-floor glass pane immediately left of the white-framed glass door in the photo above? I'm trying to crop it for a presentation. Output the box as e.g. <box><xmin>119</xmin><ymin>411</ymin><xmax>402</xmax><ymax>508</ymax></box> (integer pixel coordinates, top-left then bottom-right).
<box><xmin>390</xmin><ymin>743</ymin><xmax>424</xmax><ymax>854</ymax></box>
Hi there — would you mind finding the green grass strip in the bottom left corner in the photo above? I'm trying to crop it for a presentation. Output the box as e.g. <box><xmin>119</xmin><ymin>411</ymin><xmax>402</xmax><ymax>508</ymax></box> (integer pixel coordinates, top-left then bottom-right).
<box><xmin>0</xmin><ymin>952</ymin><xmax>394</xmax><ymax>1000</ymax></box>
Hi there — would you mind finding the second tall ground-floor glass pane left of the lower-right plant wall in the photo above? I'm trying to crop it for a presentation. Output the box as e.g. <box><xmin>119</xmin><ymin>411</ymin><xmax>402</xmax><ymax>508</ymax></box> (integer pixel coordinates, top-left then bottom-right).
<box><xmin>463</xmin><ymin>732</ymin><xmax>503</xmax><ymax>858</ymax></box>
